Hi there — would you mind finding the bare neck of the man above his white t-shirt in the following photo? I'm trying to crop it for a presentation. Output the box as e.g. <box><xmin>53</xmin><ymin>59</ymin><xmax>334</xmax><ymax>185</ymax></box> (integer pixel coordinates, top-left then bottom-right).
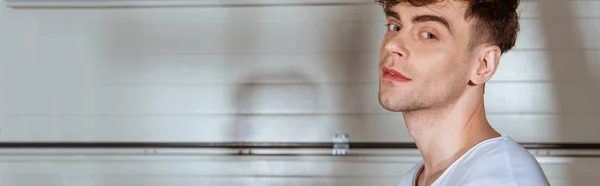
<box><xmin>404</xmin><ymin>92</ymin><xmax>500</xmax><ymax>184</ymax></box>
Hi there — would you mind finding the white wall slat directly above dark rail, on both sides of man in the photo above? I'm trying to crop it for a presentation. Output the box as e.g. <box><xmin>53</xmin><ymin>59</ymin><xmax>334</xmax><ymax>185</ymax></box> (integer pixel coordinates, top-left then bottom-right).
<box><xmin>0</xmin><ymin>114</ymin><xmax>600</xmax><ymax>143</ymax></box>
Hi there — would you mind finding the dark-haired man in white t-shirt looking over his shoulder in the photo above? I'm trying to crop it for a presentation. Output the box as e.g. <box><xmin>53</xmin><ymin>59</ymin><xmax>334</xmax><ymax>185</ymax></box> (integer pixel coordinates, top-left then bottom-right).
<box><xmin>378</xmin><ymin>0</ymin><xmax>549</xmax><ymax>186</ymax></box>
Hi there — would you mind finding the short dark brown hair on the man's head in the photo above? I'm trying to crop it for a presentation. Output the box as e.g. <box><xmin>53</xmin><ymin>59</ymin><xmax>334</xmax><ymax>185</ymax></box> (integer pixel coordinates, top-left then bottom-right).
<box><xmin>375</xmin><ymin>0</ymin><xmax>520</xmax><ymax>53</ymax></box>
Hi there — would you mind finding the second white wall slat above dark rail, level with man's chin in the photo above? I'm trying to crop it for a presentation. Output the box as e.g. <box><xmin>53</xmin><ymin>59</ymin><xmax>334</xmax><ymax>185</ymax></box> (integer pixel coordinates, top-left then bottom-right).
<box><xmin>1</xmin><ymin>83</ymin><xmax>564</xmax><ymax>116</ymax></box>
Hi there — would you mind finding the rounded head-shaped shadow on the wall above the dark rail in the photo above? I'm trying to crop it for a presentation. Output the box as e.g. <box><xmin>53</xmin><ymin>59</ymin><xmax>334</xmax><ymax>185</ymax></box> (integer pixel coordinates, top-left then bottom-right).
<box><xmin>230</xmin><ymin>72</ymin><xmax>322</xmax><ymax>142</ymax></box>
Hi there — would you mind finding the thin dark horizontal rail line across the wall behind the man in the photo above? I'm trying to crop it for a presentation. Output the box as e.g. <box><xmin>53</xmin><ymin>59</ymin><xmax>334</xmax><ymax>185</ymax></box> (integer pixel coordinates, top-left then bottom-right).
<box><xmin>0</xmin><ymin>142</ymin><xmax>600</xmax><ymax>150</ymax></box>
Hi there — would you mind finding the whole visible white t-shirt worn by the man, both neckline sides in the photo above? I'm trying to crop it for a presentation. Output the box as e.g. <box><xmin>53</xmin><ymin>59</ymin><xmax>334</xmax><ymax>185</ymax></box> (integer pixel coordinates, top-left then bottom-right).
<box><xmin>400</xmin><ymin>135</ymin><xmax>550</xmax><ymax>186</ymax></box>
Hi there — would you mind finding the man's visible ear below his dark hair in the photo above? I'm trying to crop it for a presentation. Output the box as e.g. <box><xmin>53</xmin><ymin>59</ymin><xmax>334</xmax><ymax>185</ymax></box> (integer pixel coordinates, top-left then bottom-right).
<box><xmin>471</xmin><ymin>45</ymin><xmax>502</xmax><ymax>85</ymax></box>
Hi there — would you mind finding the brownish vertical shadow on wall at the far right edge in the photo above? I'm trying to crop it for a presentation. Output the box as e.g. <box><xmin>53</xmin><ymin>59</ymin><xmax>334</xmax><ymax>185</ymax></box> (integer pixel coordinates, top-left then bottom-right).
<box><xmin>538</xmin><ymin>0</ymin><xmax>600</xmax><ymax>185</ymax></box>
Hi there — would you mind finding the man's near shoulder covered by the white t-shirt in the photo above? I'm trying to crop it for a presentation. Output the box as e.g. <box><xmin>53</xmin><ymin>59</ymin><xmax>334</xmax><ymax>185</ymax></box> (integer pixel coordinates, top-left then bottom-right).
<box><xmin>454</xmin><ymin>136</ymin><xmax>549</xmax><ymax>186</ymax></box>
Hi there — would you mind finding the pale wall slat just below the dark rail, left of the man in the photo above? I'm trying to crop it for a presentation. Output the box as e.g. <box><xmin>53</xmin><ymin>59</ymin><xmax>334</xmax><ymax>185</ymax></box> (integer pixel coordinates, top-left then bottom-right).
<box><xmin>0</xmin><ymin>157</ymin><xmax>413</xmax><ymax>177</ymax></box>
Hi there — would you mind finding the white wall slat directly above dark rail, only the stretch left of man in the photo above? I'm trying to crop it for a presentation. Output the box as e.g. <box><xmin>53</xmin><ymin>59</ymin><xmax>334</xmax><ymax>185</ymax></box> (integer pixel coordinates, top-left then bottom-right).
<box><xmin>0</xmin><ymin>115</ymin><xmax>412</xmax><ymax>142</ymax></box>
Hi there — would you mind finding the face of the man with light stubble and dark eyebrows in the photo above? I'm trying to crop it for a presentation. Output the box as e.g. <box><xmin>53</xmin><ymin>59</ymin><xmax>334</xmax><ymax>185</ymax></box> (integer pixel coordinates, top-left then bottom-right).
<box><xmin>379</xmin><ymin>1</ymin><xmax>473</xmax><ymax>112</ymax></box>
